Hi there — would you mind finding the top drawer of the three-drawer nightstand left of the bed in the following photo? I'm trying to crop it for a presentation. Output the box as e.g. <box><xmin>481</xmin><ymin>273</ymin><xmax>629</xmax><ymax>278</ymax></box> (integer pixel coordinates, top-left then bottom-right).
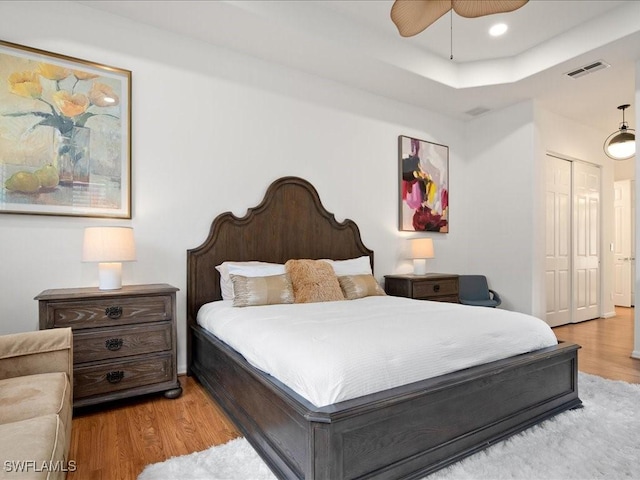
<box><xmin>47</xmin><ymin>295</ymin><xmax>172</xmax><ymax>330</ymax></box>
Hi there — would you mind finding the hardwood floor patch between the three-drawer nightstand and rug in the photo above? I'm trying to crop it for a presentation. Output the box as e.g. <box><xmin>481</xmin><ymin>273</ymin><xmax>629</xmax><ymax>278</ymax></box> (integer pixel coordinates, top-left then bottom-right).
<box><xmin>67</xmin><ymin>375</ymin><xmax>240</xmax><ymax>480</ymax></box>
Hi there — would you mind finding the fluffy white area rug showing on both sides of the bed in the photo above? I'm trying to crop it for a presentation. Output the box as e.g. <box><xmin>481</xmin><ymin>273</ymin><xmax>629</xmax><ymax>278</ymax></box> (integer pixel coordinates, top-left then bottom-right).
<box><xmin>138</xmin><ymin>373</ymin><xmax>640</xmax><ymax>480</ymax></box>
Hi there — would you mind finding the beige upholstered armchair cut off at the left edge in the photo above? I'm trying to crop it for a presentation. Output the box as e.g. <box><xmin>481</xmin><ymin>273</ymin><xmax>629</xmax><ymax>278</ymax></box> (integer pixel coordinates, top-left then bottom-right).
<box><xmin>0</xmin><ymin>328</ymin><xmax>73</xmax><ymax>479</ymax></box>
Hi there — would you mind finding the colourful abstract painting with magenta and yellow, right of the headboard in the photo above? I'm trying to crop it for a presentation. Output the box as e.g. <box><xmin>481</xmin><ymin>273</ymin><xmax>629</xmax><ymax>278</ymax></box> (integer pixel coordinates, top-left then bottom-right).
<box><xmin>398</xmin><ymin>135</ymin><xmax>449</xmax><ymax>233</ymax></box>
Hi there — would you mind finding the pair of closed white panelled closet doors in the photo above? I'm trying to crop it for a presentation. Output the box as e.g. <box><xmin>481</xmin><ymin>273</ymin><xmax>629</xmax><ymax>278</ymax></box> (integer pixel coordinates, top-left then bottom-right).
<box><xmin>545</xmin><ymin>154</ymin><xmax>601</xmax><ymax>326</ymax></box>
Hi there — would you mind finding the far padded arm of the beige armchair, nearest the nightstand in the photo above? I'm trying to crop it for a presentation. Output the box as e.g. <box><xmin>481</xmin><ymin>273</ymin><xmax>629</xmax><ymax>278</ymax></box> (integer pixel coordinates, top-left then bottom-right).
<box><xmin>0</xmin><ymin>328</ymin><xmax>73</xmax><ymax>385</ymax></box>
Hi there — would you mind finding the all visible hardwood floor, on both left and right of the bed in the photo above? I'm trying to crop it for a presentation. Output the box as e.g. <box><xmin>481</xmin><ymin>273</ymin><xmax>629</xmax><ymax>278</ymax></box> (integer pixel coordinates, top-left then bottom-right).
<box><xmin>67</xmin><ymin>308</ymin><xmax>640</xmax><ymax>480</ymax></box>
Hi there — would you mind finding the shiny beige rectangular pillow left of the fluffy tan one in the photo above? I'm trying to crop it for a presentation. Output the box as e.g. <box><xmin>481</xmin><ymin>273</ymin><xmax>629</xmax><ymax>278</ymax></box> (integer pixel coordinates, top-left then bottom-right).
<box><xmin>229</xmin><ymin>273</ymin><xmax>294</xmax><ymax>307</ymax></box>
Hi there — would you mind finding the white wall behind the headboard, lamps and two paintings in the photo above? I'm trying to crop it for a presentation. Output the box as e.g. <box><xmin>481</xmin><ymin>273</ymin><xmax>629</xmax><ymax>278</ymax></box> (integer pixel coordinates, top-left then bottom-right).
<box><xmin>0</xmin><ymin>2</ymin><xmax>466</xmax><ymax>372</ymax></box>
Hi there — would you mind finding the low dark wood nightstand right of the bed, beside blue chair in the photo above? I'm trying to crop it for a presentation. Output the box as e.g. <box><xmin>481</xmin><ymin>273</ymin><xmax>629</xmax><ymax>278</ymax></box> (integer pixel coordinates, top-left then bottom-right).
<box><xmin>384</xmin><ymin>273</ymin><xmax>458</xmax><ymax>303</ymax></box>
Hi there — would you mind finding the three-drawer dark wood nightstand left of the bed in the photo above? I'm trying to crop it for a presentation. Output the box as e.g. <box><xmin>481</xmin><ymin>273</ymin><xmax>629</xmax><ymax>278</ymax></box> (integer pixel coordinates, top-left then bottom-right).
<box><xmin>35</xmin><ymin>284</ymin><xmax>182</xmax><ymax>407</ymax></box>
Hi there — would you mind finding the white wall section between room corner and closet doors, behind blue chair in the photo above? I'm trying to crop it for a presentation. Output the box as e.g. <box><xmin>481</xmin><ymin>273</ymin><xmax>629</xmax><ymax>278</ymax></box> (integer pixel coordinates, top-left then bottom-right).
<box><xmin>460</xmin><ymin>102</ymin><xmax>538</xmax><ymax>315</ymax></box>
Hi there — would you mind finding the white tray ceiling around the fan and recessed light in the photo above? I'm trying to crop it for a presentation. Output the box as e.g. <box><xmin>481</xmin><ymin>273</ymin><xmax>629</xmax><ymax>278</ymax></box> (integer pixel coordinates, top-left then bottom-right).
<box><xmin>79</xmin><ymin>0</ymin><xmax>640</xmax><ymax>131</ymax></box>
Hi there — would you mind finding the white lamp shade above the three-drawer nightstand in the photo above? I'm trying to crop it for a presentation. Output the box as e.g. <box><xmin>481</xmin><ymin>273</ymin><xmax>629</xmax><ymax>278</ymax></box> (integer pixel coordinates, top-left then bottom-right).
<box><xmin>82</xmin><ymin>227</ymin><xmax>136</xmax><ymax>262</ymax></box>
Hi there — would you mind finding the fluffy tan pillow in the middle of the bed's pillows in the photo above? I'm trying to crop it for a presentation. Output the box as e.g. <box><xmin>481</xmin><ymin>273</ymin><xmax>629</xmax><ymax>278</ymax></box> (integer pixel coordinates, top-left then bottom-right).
<box><xmin>284</xmin><ymin>260</ymin><xmax>344</xmax><ymax>303</ymax></box>
